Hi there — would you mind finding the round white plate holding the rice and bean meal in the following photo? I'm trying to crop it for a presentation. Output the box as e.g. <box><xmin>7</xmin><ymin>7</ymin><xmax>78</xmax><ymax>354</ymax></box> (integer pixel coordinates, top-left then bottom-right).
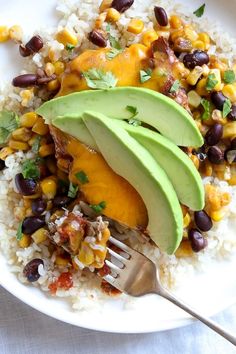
<box><xmin>0</xmin><ymin>0</ymin><xmax>236</xmax><ymax>333</ymax></box>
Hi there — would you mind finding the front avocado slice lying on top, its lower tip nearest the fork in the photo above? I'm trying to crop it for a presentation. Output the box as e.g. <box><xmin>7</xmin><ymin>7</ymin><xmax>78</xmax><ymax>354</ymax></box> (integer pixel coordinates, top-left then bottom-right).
<box><xmin>83</xmin><ymin>112</ymin><xmax>183</xmax><ymax>254</ymax></box>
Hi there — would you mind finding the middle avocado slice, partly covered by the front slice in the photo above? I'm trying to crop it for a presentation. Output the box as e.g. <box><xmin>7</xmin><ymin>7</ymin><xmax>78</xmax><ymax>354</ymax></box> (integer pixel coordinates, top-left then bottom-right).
<box><xmin>116</xmin><ymin>121</ymin><xmax>205</xmax><ymax>210</ymax></box>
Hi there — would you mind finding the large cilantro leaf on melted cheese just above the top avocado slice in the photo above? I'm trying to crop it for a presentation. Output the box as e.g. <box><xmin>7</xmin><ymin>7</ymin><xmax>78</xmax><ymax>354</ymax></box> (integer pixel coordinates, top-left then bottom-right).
<box><xmin>83</xmin><ymin>69</ymin><xmax>118</xmax><ymax>90</ymax></box>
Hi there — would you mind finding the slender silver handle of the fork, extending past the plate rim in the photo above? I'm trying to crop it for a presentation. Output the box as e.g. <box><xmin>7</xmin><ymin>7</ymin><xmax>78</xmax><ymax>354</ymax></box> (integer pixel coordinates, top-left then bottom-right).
<box><xmin>157</xmin><ymin>288</ymin><xmax>236</xmax><ymax>346</ymax></box>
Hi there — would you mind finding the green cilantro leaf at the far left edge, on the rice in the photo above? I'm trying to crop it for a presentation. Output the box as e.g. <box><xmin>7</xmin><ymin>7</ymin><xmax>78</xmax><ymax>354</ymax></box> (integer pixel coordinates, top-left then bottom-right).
<box><xmin>0</xmin><ymin>111</ymin><xmax>19</xmax><ymax>145</ymax></box>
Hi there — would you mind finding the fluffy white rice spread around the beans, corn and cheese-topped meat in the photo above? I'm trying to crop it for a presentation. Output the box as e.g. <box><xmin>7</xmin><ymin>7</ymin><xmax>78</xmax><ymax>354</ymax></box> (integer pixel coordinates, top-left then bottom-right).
<box><xmin>0</xmin><ymin>0</ymin><xmax>236</xmax><ymax>310</ymax></box>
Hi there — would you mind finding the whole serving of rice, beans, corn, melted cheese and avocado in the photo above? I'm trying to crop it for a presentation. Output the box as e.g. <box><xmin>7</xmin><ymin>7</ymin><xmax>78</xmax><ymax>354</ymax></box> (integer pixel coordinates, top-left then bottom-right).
<box><xmin>0</xmin><ymin>0</ymin><xmax>236</xmax><ymax>309</ymax></box>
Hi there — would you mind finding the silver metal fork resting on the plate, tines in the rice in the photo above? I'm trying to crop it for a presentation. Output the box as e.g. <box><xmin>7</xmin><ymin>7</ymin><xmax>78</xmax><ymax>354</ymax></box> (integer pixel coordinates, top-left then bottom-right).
<box><xmin>103</xmin><ymin>237</ymin><xmax>236</xmax><ymax>346</ymax></box>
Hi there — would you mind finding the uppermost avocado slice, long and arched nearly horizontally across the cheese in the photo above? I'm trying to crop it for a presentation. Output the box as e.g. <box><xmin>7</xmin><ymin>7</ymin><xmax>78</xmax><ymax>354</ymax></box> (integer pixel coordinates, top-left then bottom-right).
<box><xmin>36</xmin><ymin>87</ymin><xmax>203</xmax><ymax>147</ymax></box>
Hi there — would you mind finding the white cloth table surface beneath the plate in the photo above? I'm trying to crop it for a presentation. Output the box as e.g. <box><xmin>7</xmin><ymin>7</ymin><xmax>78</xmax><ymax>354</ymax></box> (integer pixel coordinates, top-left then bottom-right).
<box><xmin>0</xmin><ymin>288</ymin><xmax>236</xmax><ymax>354</ymax></box>
